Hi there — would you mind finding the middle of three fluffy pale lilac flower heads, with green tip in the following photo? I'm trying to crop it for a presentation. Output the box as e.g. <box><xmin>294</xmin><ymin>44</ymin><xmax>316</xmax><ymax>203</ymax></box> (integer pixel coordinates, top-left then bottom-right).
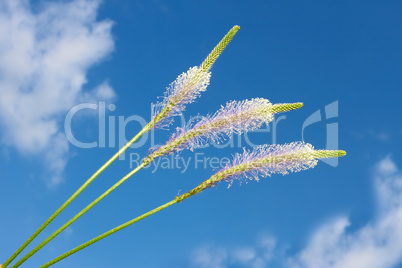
<box><xmin>144</xmin><ymin>98</ymin><xmax>303</xmax><ymax>163</ymax></box>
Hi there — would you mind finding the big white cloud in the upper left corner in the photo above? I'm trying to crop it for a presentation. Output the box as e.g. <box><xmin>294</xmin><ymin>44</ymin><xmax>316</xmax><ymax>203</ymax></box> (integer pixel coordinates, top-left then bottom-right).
<box><xmin>0</xmin><ymin>0</ymin><xmax>115</xmax><ymax>186</ymax></box>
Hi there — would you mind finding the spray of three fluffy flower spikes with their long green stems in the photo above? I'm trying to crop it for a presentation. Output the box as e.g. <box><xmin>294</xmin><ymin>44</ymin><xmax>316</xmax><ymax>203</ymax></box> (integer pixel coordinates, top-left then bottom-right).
<box><xmin>0</xmin><ymin>26</ymin><xmax>346</xmax><ymax>268</ymax></box>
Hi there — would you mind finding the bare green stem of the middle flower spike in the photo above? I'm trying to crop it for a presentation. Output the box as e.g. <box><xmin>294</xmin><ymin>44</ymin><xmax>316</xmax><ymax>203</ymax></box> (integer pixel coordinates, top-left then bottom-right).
<box><xmin>11</xmin><ymin>163</ymin><xmax>147</xmax><ymax>268</ymax></box>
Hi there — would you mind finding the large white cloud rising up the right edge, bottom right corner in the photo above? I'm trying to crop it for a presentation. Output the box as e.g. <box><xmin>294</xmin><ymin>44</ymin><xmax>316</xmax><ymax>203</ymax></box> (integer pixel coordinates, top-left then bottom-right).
<box><xmin>288</xmin><ymin>157</ymin><xmax>402</xmax><ymax>268</ymax></box>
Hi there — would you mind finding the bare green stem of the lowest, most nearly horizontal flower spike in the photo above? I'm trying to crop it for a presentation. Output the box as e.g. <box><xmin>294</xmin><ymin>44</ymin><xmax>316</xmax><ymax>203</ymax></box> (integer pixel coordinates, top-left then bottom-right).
<box><xmin>39</xmin><ymin>199</ymin><xmax>180</xmax><ymax>268</ymax></box>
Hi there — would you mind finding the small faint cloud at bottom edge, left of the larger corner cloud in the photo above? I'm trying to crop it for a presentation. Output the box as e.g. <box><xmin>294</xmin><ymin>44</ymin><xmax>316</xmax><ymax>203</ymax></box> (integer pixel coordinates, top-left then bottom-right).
<box><xmin>191</xmin><ymin>235</ymin><xmax>276</xmax><ymax>268</ymax></box>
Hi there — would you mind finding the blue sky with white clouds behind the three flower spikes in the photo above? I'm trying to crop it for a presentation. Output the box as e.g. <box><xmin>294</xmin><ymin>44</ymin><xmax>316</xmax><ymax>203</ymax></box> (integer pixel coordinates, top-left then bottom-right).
<box><xmin>0</xmin><ymin>0</ymin><xmax>402</xmax><ymax>268</ymax></box>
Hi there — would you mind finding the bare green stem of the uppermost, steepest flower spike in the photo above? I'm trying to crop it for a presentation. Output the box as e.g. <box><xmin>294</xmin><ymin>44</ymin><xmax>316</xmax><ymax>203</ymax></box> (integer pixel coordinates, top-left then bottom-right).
<box><xmin>3</xmin><ymin>122</ymin><xmax>154</xmax><ymax>268</ymax></box>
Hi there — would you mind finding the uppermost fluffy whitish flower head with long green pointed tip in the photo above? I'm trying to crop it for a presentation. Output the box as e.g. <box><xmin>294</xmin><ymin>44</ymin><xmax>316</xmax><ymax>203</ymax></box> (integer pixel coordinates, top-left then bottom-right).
<box><xmin>151</xmin><ymin>26</ymin><xmax>240</xmax><ymax>128</ymax></box>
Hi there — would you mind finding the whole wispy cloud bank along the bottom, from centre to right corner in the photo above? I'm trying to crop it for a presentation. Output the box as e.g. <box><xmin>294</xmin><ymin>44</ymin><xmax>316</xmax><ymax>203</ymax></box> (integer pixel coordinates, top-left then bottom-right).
<box><xmin>192</xmin><ymin>157</ymin><xmax>402</xmax><ymax>268</ymax></box>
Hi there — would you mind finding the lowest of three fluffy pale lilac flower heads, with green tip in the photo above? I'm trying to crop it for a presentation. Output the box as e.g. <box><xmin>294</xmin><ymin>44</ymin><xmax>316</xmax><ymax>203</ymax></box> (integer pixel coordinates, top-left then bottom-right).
<box><xmin>176</xmin><ymin>142</ymin><xmax>346</xmax><ymax>202</ymax></box>
